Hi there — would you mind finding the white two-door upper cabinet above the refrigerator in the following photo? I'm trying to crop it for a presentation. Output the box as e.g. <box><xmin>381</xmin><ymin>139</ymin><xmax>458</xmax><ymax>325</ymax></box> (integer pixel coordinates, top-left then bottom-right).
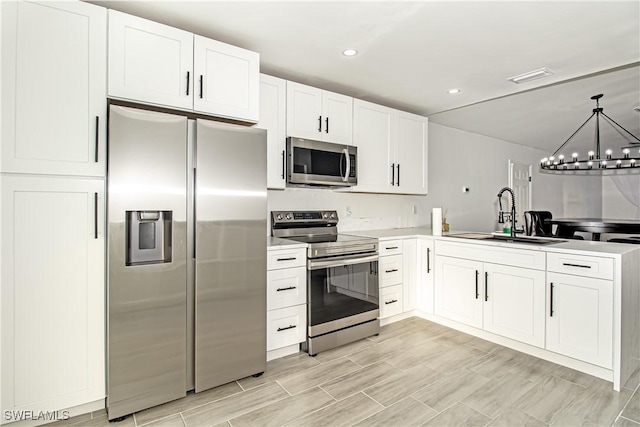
<box><xmin>109</xmin><ymin>10</ymin><xmax>260</xmax><ymax>122</ymax></box>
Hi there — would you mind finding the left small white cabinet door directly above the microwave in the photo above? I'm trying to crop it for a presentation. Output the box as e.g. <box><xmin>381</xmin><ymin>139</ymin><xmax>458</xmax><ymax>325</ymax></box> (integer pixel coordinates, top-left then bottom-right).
<box><xmin>287</xmin><ymin>82</ymin><xmax>322</xmax><ymax>140</ymax></box>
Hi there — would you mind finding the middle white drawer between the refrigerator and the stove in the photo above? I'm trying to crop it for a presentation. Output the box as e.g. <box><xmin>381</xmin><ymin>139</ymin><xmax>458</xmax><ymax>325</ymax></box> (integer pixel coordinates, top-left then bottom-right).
<box><xmin>267</xmin><ymin>267</ymin><xmax>307</xmax><ymax>310</ymax></box>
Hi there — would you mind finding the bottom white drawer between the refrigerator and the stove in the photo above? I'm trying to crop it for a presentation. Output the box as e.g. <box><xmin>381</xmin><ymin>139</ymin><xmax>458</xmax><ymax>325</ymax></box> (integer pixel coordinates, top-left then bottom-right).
<box><xmin>267</xmin><ymin>304</ymin><xmax>307</xmax><ymax>351</ymax></box>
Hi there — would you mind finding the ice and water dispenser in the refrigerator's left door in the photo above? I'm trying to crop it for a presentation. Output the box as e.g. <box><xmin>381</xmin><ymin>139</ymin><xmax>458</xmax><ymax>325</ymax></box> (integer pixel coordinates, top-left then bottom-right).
<box><xmin>126</xmin><ymin>211</ymin><xmax>173</xmax><ymax>266</ymax></box>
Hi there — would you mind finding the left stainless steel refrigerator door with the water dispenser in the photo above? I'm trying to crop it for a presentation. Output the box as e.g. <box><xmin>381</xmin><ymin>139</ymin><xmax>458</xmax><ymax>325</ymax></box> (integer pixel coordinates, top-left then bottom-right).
<box><xmin>107</xmin><ymin>106</ymin><xmax>187</xmax><ymax>419</ymax></box>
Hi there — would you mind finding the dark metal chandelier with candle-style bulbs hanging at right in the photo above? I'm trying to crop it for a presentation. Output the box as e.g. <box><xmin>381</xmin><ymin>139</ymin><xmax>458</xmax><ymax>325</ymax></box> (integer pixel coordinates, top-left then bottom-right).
<box><xmin>540</xmin><ymin>94</ymin><xmax>640</xmax><ymax>172</ymax></box>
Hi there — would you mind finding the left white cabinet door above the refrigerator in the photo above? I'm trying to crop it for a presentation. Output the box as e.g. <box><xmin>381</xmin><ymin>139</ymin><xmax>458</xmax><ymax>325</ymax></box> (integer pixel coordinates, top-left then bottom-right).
<box><xmin>109</xmin><ymin>9</ymin><xmax>194</xmax><ymax>109</ymax></box>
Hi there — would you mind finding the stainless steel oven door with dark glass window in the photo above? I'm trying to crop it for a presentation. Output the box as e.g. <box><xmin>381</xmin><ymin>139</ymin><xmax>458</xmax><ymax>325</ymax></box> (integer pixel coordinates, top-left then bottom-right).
<box><xmin>307</xmin><ymin>254</ymin><xmax>379</xmax><ymax>337</ymax></box>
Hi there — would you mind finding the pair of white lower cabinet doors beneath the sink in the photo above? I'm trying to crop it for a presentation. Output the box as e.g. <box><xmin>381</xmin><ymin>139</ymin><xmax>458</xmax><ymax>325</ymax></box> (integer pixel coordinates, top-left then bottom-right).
<box><xmin>435</xmin><ymin>256</ymin><xmax>545</xmax><ymax>347</ymax></box>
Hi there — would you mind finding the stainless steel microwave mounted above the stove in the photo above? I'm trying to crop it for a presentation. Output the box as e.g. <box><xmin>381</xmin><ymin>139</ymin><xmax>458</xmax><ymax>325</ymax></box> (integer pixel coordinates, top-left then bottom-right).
<box><xmin>287</xmin><ymin>137</ymin><xmax>358</xmax><ymax>187</ymax></box>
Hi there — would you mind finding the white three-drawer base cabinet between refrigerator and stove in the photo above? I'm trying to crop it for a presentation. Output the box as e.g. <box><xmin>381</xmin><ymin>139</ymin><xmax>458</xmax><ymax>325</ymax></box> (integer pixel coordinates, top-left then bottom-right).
<box><xmin>267</xmin><ymin>248</ymin><xmax>307</xmax><ymax>360</ymax></box>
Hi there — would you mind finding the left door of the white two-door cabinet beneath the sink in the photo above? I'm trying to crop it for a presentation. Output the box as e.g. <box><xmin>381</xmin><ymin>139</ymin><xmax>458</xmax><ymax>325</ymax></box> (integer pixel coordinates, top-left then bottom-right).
<box><xmin>435</xmin><ymin>256</ymin><xmax>483</xmax><ymax>328</ymax></box>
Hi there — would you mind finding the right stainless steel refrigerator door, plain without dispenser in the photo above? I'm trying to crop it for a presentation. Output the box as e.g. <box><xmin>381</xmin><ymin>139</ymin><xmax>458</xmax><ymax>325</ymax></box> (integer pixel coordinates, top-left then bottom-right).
<box><xmin>195</xmin><ymin>120</ymin><xmax>267</xmax><ymax>392</ymax></box>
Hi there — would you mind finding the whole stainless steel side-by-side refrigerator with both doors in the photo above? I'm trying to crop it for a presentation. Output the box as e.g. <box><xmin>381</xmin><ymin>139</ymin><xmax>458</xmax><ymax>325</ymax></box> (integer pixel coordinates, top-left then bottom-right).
<box><xmin>107</xmin><ymin>105</ymin><xmax>267</xmax><ymax>420</ymax></box>
